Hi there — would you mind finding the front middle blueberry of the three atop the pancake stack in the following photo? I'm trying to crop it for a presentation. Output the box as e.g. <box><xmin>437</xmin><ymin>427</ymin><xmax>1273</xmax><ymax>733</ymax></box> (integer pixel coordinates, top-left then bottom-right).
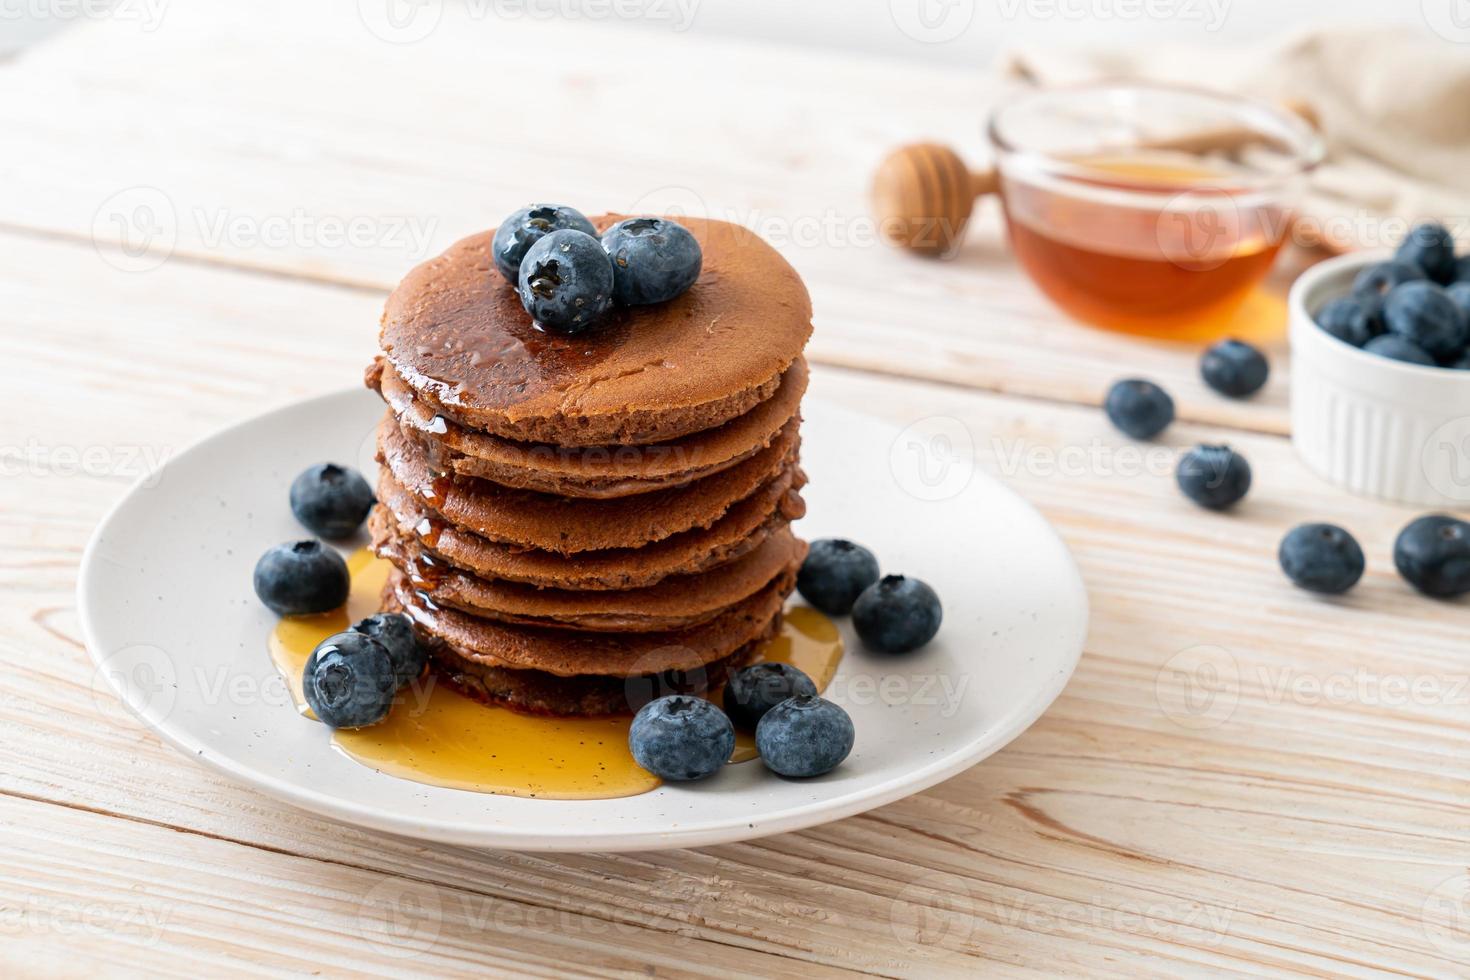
<box><xmin>520</xmin><ymin>229</ymin><xmax>613</xmax><ymax>334</ymax></box>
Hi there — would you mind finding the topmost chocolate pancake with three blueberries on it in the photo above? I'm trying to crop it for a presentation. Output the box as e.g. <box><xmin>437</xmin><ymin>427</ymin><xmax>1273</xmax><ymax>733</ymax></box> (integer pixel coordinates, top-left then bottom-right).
<box><xmin>381</xmin><ymin>215</ymin><xmax>811</xmax><ymax>447</ymax></box>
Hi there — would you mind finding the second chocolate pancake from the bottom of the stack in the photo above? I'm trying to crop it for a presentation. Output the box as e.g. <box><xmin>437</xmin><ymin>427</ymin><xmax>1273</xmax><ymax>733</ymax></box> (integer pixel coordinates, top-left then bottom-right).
<box><xmin>388</xmin><ymin>564</ymin><xmax>797</xmax><ymax>677</ymax></box>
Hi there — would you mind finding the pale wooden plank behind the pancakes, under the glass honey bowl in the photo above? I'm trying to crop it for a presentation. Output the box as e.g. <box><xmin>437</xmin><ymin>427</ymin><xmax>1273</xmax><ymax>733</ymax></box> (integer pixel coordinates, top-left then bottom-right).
<box><xmin>0</xmin><ymin>3</ymin><xmax>1311</xmax><ymax>432</ymax></box>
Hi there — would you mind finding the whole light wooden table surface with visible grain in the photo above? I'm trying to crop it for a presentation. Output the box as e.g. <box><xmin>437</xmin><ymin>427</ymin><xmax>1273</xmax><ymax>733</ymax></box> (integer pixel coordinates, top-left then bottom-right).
<box><xmin>0</xmin><ymin>0</ymin><xmax>1470</xmax><ymax>977</ymax></box>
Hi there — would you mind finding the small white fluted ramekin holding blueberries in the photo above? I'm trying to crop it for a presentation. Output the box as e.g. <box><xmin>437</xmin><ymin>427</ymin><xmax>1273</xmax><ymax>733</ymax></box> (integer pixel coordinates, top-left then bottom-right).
<box><xmin>1288</xmin><ymin>251</ymin><xmax>1470</xmax><ymax>507</ymax></box>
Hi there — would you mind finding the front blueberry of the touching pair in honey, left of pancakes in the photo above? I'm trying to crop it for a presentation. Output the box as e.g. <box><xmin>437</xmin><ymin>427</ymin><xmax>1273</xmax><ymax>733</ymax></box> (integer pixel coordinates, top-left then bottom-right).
<box><xmin>301</xmin><ymin>632</ymin><xmax>398</xmax><ymax>729</ymax></box>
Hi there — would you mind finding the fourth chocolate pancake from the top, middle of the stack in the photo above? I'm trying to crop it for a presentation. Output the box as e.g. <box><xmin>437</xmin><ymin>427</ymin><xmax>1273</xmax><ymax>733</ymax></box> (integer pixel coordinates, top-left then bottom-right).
<box><xmin>367</xmin><ymin>463</ymin><xmax>806</xmax><ymax>589</ymax></box>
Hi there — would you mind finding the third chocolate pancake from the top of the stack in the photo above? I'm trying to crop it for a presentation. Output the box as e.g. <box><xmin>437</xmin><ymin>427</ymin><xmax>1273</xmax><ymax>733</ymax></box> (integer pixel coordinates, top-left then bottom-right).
<box><xmin>378</xmin><ymin>411</ymin><xmax>800</xmax><ymax>554</ymax></box>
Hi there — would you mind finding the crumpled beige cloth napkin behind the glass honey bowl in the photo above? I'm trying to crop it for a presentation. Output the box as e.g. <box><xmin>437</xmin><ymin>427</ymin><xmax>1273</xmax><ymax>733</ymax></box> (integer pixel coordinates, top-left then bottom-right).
<box><xmin>1001</xmin><ymin>28</ymin><xmax>1470</xmax><ymax>250</ymax></box>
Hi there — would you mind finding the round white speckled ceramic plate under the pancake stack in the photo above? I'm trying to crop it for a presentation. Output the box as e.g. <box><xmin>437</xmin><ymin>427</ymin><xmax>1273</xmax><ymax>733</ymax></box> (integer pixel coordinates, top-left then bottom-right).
<box><xmin>78</xmin><ymin>389</ymin><xmax>1088</xmax><ymax>851</ymax></box>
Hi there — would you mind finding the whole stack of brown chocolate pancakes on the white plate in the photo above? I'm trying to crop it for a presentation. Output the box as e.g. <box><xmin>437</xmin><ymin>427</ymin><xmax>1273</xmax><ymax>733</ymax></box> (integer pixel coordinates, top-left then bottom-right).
<box><xmin>368</xmin><ymin>215</ymin><xmax>811</xmax><ymax>716</ymax></box>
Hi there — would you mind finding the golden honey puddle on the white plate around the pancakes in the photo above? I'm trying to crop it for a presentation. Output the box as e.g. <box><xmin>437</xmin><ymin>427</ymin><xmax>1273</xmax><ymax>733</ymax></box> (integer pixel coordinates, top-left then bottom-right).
<box><xmin>269</xmin><ymin>548</ymin><xmax>842</xmax><ymax>799</ymax></box>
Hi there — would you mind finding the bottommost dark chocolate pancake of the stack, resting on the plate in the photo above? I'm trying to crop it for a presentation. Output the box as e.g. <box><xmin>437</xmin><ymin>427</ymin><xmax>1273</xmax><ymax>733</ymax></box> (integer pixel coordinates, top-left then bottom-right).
<box><xmin>382</xmin><ymin>585</ymin><xmax>781</xmax><ymax>716</ymax></box>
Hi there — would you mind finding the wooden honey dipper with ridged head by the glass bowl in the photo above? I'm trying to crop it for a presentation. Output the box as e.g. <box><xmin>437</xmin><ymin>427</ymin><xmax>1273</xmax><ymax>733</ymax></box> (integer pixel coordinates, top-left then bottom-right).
<box><xmin>873</xmin><ymin>101</ymin><xmax>1319</xmax><ymax>256</ymax></box>
